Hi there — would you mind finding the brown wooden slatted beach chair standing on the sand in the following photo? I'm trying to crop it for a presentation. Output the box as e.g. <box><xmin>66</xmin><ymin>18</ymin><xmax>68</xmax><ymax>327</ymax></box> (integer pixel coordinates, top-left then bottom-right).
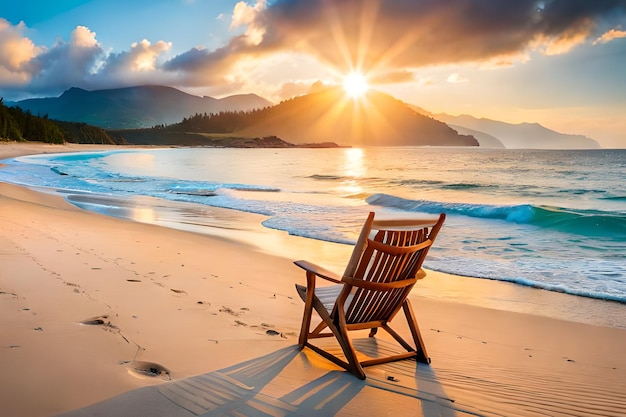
<box><xmin>294</xmin><ymin>213</ymin><xmax>445</xmax><ymax>379</ymax></box>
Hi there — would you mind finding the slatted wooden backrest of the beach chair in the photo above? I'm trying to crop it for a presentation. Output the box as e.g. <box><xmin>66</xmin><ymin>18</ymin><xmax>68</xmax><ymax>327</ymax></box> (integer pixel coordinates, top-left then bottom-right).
<box><xmin>336</xmin><ymin>213</ymin><xmax>445</xmax><ymax>324</ymax></box>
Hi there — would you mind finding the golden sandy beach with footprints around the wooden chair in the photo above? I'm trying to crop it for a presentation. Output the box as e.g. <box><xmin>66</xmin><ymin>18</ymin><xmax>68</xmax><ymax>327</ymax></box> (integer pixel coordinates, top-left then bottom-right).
<box><xmin>0</xmin><ymin>143</ymin><xmax>626</xmax><ymax>417</ymax></box>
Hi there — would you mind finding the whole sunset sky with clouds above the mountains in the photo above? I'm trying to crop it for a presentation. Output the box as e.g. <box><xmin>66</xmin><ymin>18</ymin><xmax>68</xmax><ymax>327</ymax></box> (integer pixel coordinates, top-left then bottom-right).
<box><xmin>0</xmin><ymin>0</ymin><xmax>626</xmax><ymax>148</ymax></box>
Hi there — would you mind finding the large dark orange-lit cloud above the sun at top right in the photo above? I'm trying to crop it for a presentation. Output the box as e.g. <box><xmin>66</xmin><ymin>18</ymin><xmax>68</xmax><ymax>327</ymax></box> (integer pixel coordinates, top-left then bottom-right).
<box><xmin>165</xmin><ymin>0</ymin><xmax>626</xmax><ymax>79</ymax></box>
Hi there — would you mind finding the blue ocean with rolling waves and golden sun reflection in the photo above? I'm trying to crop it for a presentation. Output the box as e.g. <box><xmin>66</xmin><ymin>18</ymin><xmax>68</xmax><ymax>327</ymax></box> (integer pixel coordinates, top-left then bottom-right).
<box><xmin>0</xmin><ymin>147</ymin><xmax>626</xmax><ymax>322</ymax></box>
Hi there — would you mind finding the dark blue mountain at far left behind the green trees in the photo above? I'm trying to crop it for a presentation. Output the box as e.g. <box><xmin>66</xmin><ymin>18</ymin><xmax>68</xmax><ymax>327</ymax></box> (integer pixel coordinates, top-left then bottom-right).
<box><xmin>7</xmin><ymin>86</ymin><xmax>272</xmax><ymax>129</ymax></box>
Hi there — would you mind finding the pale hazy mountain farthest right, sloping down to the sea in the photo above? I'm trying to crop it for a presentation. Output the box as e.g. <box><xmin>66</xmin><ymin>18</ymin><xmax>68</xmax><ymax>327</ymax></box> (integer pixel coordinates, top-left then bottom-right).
<box><xmin>433</xmin><ymin>113</ymin><xmax>600</xmax><ymax>149</ymax></box>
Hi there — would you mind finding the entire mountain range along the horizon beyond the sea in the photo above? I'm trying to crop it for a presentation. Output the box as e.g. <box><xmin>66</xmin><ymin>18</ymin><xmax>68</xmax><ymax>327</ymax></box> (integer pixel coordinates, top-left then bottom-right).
<box><xmin>6</xmin><ymin>85</ymin><xmax>600</xmax><ymax>149</ymax></box>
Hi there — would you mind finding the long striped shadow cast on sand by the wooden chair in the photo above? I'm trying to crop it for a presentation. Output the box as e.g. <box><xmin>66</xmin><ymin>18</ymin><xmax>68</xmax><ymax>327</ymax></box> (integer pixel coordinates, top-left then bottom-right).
<box><xmin>57</xmin><ymin>338</ymin><xmax>464</xmax><ymax>417</ymax></box>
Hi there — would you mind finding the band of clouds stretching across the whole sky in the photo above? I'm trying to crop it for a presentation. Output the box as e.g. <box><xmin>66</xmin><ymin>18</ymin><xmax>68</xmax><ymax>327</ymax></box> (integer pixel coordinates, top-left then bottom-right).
<box><xmin>0</xmin><ymin>0</ymin><xmax>626</xmax><ymax>100</ymax></box>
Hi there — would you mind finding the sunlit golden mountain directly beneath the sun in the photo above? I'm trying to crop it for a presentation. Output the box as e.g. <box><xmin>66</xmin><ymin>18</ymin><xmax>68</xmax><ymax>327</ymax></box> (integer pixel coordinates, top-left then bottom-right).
<box><xmin>233</xmin><ymin>86</ymin><xmax>478</xmax><ymax>146</ymax></box>
